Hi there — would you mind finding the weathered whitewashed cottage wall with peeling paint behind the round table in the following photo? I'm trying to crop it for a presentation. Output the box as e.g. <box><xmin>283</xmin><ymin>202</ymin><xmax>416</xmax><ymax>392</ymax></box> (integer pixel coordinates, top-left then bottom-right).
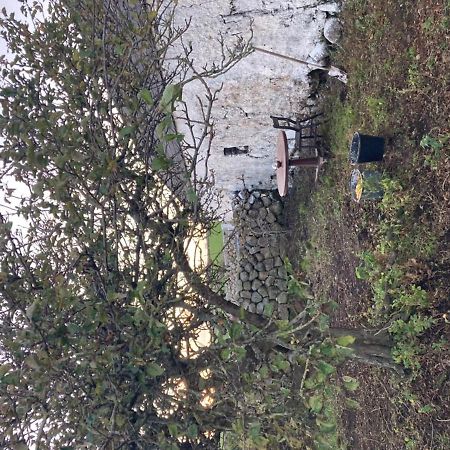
<box><xmin>172</xmin><ymin>0</ymin><xmax>338</xmax><ymax>206</ymax></box>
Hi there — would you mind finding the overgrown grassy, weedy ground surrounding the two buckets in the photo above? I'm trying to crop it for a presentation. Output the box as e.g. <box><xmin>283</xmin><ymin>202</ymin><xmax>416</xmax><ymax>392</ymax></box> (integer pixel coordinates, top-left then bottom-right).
<box><xmin>288</xmin><ymin>0</ymin><xmax>450</xmax><ymax>449</ymax></box>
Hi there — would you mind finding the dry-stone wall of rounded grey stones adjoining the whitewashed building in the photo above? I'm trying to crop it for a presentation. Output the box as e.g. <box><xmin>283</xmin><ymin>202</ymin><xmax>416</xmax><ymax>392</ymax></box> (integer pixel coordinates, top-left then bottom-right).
<box><xmin>230</xmin><ymin>190</ymin><xmax>288</xmax><ymax>318</ymax></box>
